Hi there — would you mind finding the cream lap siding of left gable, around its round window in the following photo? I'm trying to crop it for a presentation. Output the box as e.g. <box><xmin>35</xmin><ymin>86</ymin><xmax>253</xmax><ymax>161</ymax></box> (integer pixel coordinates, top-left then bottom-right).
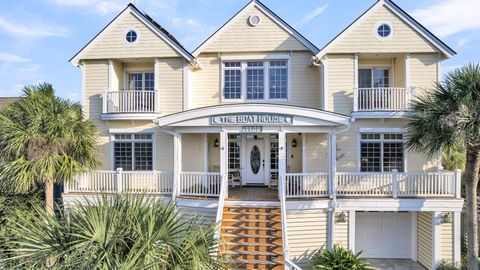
<box><xmin>82</xmin><ymin>13</ymin><xmax>180</xmax><ymax>59</ymax></box>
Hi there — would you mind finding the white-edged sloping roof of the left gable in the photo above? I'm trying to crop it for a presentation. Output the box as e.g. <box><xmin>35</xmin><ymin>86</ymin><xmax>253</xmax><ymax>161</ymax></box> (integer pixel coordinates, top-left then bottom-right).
<box><xmin>69</xmin><ymin>3</ymin><xmax>194</xmax><ymax>65</ymax></box>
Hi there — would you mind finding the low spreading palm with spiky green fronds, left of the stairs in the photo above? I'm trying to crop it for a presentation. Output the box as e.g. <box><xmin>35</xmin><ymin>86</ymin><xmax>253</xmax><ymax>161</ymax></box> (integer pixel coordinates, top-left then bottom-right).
<box><xmin>2</xmin><ymin>195</ymin><xmax>224</xmax><ymax>270</ymax></box>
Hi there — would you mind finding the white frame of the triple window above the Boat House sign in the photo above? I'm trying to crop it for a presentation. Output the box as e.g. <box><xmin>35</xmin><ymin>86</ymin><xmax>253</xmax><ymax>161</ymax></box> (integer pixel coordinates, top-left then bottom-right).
<box><xmin>220</xmin><ymin>55</ymin><xmax>292</xmax><ymax>103</ymax></box>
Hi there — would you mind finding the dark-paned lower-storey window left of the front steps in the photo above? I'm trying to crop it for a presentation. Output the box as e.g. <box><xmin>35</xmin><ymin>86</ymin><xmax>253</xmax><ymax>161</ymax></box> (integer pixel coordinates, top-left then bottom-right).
<box><xmin>113</xmin><ymin>133</ymin><xmax>153</xmax><ymax>171</ymax></box>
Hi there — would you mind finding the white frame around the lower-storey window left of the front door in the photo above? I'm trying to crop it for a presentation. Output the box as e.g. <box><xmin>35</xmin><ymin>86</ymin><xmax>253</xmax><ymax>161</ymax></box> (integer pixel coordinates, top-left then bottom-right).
<box><xmin>109</xmin><ymin>128</ymin><xmax>157</xmax><ymax>172</ymax></box>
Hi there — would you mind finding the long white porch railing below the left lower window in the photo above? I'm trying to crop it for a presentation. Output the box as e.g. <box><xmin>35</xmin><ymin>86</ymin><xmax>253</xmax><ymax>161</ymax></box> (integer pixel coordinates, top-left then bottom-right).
<box><xmin>65</xmin><ymin>168</ymin><xmax>173</xmax><ymax>194</ymax></box>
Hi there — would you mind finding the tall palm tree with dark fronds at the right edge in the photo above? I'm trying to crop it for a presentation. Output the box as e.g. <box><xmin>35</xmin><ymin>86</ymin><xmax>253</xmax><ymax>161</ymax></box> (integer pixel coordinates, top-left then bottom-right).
<box><xmin>408</xmin><ymin>64</ymin><xmax>480</xmax><ymax>269</ymax></box>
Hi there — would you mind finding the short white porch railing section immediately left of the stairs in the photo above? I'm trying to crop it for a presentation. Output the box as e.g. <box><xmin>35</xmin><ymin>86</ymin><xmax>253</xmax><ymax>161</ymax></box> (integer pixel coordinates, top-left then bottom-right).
<box><xmin>178</xmin><ymin>172</ymin><xmax>221</xmax><ymax>197</ymax></box>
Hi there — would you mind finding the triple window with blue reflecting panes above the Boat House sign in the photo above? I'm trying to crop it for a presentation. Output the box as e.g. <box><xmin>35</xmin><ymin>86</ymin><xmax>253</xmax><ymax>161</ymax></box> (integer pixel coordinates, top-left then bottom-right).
<box><xmin>223</xmin><ymin>60</ymin><xmax>289</xmax><ymax>101</ymax></box>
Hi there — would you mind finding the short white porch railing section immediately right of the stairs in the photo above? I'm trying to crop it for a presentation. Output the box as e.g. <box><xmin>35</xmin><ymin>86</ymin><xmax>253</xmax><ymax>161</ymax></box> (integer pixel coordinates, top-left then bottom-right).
<box><xmin>285</xmin><ymin>173</ymin><xmax>328</xmax><ymax>198</ymax></box>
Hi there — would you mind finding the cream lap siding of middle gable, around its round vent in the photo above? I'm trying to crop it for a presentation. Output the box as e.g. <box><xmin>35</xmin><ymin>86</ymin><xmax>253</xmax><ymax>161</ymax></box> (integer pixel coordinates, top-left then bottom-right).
<box><xmin>202</xmin><ymin>6</ymin><xmax>307</xmax><ymax>52</ymax></box>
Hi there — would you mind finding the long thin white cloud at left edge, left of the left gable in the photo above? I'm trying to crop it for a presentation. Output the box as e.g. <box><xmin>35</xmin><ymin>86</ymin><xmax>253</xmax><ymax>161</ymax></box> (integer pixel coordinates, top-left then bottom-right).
<box><xmin>0</xmin><ymin>17</ymin><xmax>68</xmax><ymax>39</ymax></box>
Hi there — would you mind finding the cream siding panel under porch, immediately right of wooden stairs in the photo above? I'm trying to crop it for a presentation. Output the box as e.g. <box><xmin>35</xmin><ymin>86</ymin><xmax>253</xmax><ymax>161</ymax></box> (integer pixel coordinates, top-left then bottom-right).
<box><xmin>287</xmin><ymin>210</ymin><xmax>327</xmax><ymax>270</ymax></box>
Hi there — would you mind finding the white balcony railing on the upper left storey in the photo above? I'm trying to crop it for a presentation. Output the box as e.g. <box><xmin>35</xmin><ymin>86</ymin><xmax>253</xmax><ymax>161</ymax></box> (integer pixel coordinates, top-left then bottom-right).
<box><xmin>102</xmin><ymin>90</ymin><xmax>160</xmax><ymax>113</ymax></box>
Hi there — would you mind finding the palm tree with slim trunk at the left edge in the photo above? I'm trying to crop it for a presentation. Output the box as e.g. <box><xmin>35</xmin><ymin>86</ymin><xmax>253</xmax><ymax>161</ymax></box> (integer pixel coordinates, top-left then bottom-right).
<box><xmin>0</xmin><ymin>83</ymin><xmax>98</xmax><ymax>213</ymax></box>
